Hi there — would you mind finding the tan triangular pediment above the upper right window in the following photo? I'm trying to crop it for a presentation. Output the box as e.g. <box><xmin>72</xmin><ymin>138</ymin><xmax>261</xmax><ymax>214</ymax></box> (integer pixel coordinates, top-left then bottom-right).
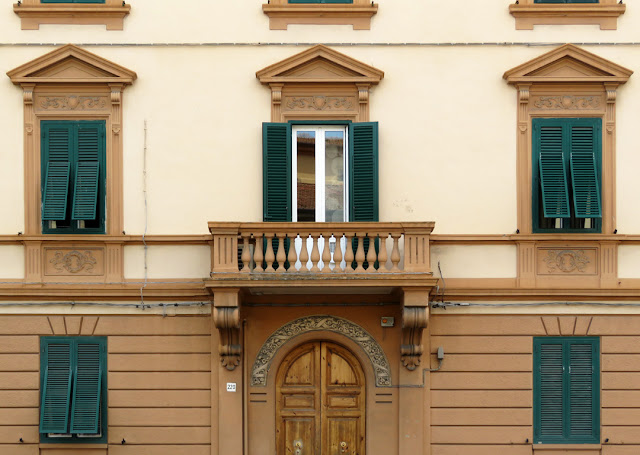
<box><xmin>504</xmin><ymin>44</ymin><xmax>633</xmax><ymax>84</ymax></box>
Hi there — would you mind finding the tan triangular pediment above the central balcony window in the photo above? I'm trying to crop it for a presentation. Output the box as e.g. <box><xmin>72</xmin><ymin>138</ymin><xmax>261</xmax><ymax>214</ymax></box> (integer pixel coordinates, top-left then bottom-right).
<box><xmin>256</xmin><ymin>44</ymin><xmax>384</xmax><ymax>84</ymax></box>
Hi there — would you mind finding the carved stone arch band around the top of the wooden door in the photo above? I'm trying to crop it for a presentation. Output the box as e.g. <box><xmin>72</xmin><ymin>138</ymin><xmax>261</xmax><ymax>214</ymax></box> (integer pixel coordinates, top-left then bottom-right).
<box><xmin>251</xmin><ymin>315</ymin><xmax>391</xmax><ymax>387</ymax></box>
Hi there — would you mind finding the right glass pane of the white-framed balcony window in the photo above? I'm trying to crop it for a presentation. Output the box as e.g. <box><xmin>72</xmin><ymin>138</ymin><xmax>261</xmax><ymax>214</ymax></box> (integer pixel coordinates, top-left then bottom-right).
<box><xmin>324</xmin><ymin>131</ymin><xmax>344</xmax><ymax>222</ymax></box>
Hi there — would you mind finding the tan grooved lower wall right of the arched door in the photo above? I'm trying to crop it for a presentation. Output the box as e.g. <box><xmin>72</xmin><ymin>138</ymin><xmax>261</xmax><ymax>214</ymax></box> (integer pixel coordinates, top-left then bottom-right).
<box><xmin>431</xmin><ymin>315</ymin><xmax>640</xmax><ymax>455</ymax></box>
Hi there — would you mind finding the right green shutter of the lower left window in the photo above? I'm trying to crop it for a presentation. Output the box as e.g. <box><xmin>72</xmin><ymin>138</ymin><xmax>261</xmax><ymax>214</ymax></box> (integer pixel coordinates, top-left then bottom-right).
<box><xmin>71</xmin><ymin>342</ymin><xmax>104</xmax><ymax>434</ymax></box>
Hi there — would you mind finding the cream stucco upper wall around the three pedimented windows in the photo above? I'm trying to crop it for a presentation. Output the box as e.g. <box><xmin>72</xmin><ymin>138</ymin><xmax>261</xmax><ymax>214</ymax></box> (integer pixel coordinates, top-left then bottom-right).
<box><xmin>0</xmin><ymin>0</ymin><xmax>640</xmax><ymax>277</ymax></box>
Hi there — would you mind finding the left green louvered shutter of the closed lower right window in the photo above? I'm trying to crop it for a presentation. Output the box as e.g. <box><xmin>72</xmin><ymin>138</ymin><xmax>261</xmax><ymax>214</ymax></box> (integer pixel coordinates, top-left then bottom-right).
<box><xmin>534</xmin><ymin>341</ymin><xmax>563</xmax><ymax>442</ymax></box>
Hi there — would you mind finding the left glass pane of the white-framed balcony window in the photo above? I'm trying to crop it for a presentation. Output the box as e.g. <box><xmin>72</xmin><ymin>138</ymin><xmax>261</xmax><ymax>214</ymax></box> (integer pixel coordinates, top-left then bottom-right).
<box><xmin>296</xmin><ymin>131</ymin><xmax>316</xmax><ymax>221</ymax></box>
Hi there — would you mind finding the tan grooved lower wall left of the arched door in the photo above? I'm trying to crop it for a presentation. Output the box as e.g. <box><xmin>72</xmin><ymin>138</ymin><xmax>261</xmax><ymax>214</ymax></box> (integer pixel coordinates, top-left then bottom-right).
<box><xmin>0</xmin><ymin>315</ymin><xmax>212</xmax><ymax>455</ymax></box>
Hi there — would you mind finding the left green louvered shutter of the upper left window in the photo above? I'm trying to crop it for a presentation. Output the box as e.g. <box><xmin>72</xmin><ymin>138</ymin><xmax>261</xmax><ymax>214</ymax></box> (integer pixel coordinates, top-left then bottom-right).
<box><xmin>42</xmin><ymin>122</ymin><xmax>73</xmax><ymax>221</ymax></box>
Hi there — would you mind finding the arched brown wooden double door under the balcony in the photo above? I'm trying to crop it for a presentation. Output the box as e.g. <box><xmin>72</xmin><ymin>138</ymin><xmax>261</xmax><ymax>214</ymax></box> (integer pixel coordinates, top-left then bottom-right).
<box><xmin>276</xmin><ymin>341</ymin><xmax>366</xmax><ymax>455</ymax></box>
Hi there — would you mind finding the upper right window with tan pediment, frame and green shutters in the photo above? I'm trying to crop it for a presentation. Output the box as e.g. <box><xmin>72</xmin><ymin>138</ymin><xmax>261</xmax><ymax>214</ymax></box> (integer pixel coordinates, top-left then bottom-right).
<box><xmin>504</xmin><ymin>44</ymin><xmax>633</xmax><ymax>234</ymax></box>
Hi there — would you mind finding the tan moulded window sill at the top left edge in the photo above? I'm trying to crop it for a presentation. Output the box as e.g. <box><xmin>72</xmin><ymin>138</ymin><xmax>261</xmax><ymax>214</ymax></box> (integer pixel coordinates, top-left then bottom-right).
<box><xmin>13</xmin><ymin>3</ymin><xmax>131</xmax><ymax>30</ymax></box>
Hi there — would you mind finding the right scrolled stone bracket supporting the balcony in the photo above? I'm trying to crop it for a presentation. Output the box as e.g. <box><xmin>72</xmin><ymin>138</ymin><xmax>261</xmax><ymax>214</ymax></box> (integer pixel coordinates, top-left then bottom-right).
<box><xmin>400</xmin><ymin>290</ymin><xmax>429</xmax><ymax>371</ymax></box>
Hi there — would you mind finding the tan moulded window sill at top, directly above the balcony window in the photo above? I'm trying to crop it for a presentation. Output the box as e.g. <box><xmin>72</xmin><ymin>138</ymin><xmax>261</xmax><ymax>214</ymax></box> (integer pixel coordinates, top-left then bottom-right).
<box><xmin>262</xmin><ymin>4</ymin><xmax>378</xmax><ymax>30</ymax></box>
